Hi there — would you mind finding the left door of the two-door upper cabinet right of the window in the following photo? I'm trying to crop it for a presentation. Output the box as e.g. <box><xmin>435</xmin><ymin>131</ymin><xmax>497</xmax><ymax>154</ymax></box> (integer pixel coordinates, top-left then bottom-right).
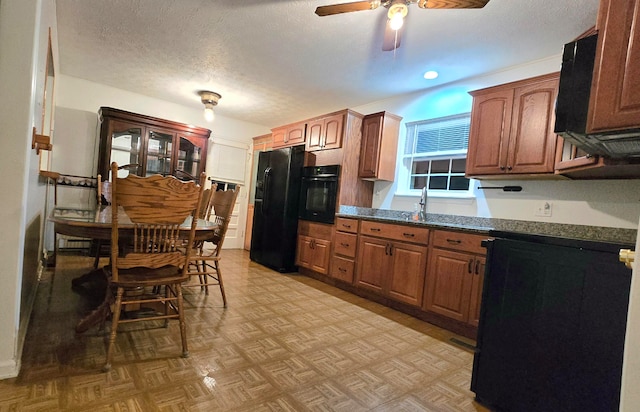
<box><xmin>466</xmin><ymin>89</ymin><xmax>513</xmax><ymax>176</ymax></box>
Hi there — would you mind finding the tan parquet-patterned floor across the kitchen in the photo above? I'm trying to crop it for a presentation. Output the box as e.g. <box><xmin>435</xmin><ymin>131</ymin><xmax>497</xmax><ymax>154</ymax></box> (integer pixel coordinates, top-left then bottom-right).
<box><xmin>0</xmin><ymin>250</ymin><xmax>486</xmax><ymax>412</ymax></box>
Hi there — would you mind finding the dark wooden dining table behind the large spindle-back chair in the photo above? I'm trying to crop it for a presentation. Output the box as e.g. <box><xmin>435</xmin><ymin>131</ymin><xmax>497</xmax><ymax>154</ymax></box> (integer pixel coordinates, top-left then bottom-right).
<box><xmin>49</xmin><ymin>205</ymin><xmax>219</xmax><ymax>333</ymax></box>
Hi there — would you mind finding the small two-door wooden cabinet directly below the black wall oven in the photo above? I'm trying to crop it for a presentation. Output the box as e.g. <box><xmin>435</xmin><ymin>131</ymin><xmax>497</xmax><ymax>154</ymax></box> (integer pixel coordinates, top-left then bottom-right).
<box><xmin>296</xmin><ymin>220</ymin><xmax>333</xmax><ymax>275</ymax></box>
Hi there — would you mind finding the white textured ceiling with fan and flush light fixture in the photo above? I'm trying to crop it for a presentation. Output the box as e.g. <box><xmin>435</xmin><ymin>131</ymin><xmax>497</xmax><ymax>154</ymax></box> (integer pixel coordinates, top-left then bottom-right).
<box><xmin>56</xmin><ymin>0</ymin><xmax>598</xmax><ymax>127</ymax></box>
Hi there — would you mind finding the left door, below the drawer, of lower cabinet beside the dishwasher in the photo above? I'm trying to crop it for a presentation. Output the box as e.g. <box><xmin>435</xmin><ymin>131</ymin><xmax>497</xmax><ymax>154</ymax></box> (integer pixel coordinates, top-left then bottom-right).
<box><xmin>424</xmin><ymin>248</ymin><xmax>475</xmax><ymax>322</ymax></box>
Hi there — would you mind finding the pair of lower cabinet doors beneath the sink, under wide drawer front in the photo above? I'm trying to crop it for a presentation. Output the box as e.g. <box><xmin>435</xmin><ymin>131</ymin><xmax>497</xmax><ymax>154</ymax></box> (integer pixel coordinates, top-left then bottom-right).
<box><xmin>356</xmin><ymin>236</ymin><xmax>428</xmax><ymax>306</ymax></box>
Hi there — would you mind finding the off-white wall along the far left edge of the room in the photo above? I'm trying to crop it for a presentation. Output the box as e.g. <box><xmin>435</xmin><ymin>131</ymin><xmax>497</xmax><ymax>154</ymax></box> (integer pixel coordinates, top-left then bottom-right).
<box><xmin>0</xmin><ymin>0</ymin><xmax>57</xmax><ymax>378</ymax></box>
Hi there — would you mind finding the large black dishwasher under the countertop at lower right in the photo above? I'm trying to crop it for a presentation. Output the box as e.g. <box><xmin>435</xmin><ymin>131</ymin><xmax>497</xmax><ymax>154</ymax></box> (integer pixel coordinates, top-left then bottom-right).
<box><xmin>471</xmin><ymin>232</ymin><xmax>632</xmax><ymax>412</ymax></box>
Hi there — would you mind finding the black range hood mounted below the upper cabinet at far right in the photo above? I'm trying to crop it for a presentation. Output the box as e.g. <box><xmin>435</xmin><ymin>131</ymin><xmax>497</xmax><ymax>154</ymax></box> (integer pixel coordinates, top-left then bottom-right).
<box><xmin>554</xmin><ymin>34</ymin><xmax>640</xmax><ymax>158</ymax></box>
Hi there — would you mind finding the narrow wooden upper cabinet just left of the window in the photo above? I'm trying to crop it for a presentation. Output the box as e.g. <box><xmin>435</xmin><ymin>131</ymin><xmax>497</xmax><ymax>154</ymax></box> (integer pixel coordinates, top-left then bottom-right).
<box><xmin>358</xmin><ymin>112</ymin><xmax>402</xmax><ymax>182</ymax></box>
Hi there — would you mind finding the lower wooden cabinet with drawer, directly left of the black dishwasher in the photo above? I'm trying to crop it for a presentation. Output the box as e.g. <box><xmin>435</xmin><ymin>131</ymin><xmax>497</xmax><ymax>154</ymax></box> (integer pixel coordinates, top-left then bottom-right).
<box><xmin>423</xmin><ymin>230</ymin><xmax>486</xmax><ymax>327</ymax></box>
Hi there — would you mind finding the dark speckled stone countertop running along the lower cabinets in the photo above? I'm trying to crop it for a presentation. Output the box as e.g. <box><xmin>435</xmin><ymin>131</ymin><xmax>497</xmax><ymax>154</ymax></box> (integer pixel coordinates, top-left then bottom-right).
<box><xmin>336</xmin><ymin>206</ymin><xmax>637</xmax><ymax>246</ymax></box>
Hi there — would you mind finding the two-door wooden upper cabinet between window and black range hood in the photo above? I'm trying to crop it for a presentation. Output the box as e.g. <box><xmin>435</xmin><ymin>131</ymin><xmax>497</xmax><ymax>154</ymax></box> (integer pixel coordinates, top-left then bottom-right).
<box><xmin>467</xmin><ymin>73</ymin><xmax>559</xmax><ymax>177</ymax></box>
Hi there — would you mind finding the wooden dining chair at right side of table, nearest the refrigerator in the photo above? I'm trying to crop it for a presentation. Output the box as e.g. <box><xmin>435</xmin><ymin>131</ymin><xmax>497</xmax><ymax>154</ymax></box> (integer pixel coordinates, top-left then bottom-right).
<box><xmin>189</xmin><ymin>185</ymin><xmax>240</xmax><ymax>307</ymax></box>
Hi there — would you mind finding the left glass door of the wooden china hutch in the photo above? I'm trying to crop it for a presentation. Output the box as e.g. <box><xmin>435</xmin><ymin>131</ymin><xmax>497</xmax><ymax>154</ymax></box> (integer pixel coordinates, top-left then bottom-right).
<box><xmin>110</xmin><ymin>122</ymin><xmax>144</xmax><ymax>180</ymax></box>
